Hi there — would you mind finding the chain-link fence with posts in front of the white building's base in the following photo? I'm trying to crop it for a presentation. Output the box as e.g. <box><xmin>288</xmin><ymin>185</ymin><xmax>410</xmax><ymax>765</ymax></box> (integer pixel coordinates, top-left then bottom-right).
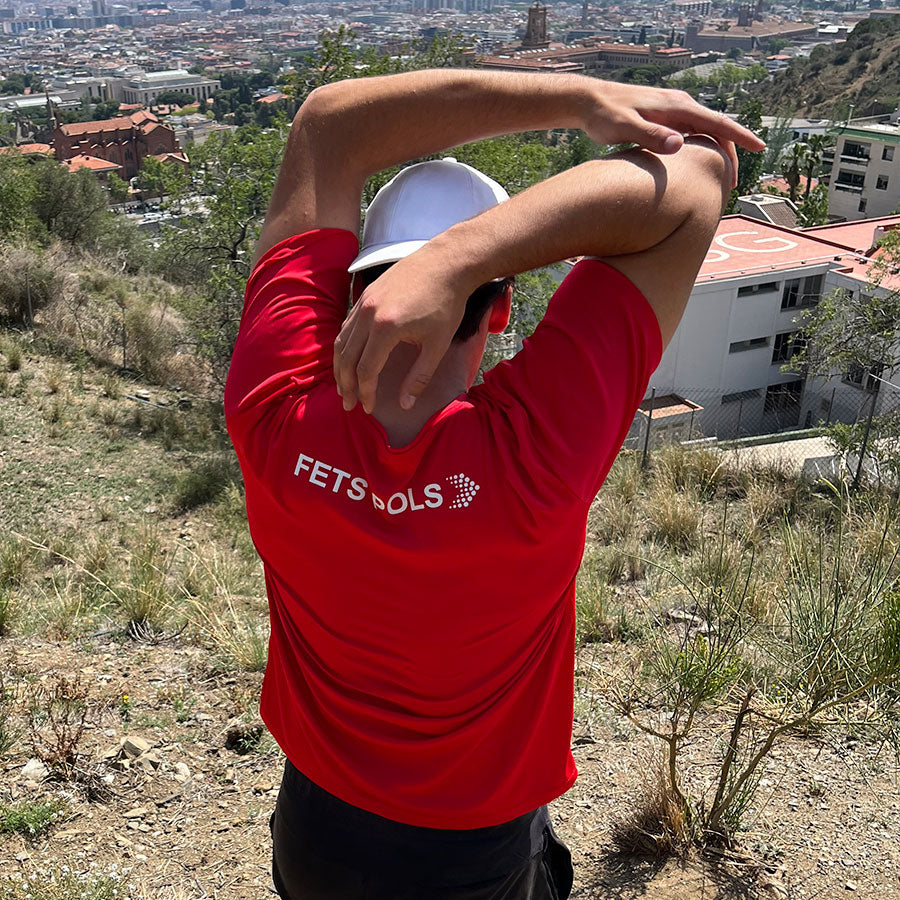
<box><xmin>625</xmin><ymin>376</ymin><xmax>900</xmax><ymax>478</ymax></box>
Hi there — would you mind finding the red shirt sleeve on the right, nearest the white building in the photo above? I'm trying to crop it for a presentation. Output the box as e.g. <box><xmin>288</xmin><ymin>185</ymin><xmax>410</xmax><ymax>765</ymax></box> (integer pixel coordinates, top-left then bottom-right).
<box><xmin>484</xmin><ymin>259</ymin><xmax>662</xmax><ymax>502</ymax></box>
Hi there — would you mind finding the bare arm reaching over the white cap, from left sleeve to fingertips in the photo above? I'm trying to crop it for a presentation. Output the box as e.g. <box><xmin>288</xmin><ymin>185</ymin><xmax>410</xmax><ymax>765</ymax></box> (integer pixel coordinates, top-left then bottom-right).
<box><xmin>254</xmin><ymin>69</ymin><xmax>763</xmax><ymax>263</ymax></box>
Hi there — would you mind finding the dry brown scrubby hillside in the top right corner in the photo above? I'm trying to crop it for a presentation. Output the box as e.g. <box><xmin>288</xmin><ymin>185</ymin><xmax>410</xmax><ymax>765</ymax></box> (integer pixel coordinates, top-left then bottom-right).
<box><xmin>754</xmin><ymin>15</ymin><xmax>900</xmax><ymax>119</ymax></box>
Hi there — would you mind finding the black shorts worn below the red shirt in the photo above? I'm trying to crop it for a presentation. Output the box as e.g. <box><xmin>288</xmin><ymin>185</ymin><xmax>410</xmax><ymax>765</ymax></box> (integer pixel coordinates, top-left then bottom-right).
<box><xmin>269</xmin><ymin>761</ymin><xmax>572</xmax><ymax>900</ymax></box>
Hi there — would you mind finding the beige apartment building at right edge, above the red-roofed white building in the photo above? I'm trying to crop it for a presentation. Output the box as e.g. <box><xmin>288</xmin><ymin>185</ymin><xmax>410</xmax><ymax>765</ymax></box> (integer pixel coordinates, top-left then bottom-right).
<box><xmin>826</xmin><ymin>117</ymin><xmax>900</xmax><ymax>222</ymax></box>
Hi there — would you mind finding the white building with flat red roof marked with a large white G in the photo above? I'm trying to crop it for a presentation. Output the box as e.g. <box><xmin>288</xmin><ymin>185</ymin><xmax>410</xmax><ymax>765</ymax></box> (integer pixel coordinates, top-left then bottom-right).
<box><xmin>631</xmin><ymin>215</ymin><xmax>900</xmax><ymax>443</ymax></box>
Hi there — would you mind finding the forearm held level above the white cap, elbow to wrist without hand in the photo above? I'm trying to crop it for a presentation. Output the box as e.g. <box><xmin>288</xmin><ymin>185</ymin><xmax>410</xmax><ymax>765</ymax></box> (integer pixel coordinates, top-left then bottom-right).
<box><xmin>304</xmin><ymin>69</ymin><xmax>599</xmax><ymax>177</ymax></box>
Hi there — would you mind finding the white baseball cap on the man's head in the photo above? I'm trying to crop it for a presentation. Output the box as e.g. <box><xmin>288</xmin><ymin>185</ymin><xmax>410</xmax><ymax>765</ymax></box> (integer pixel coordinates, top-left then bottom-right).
<box><xmin>347</xmin><ymin>156</ymin><xmax>509</xmax><ymax>272</ymax></box>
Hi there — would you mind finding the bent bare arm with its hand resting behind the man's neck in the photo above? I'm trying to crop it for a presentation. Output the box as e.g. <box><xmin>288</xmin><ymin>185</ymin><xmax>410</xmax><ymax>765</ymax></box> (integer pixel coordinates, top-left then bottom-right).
<box><xmin>335</xmin><ymin>136</ymin><xmax>733</xmax><ymax>411</ymax></box>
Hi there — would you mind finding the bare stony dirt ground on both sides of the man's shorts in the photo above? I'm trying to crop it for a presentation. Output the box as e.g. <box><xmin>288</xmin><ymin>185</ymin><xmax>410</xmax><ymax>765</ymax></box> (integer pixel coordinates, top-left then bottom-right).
<box><xmin>0</xmin><ymin>635</ymin><xmax>900</xmax><ymax>900</ymax></box>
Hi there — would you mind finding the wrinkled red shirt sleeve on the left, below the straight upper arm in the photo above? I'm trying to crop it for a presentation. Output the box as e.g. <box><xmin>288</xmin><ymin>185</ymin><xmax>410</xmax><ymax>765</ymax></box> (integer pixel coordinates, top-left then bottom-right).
<box><xmin>225</xmin><ymin>228</ymin><xmax>359</xmax><ymax>419</ymax></box>
